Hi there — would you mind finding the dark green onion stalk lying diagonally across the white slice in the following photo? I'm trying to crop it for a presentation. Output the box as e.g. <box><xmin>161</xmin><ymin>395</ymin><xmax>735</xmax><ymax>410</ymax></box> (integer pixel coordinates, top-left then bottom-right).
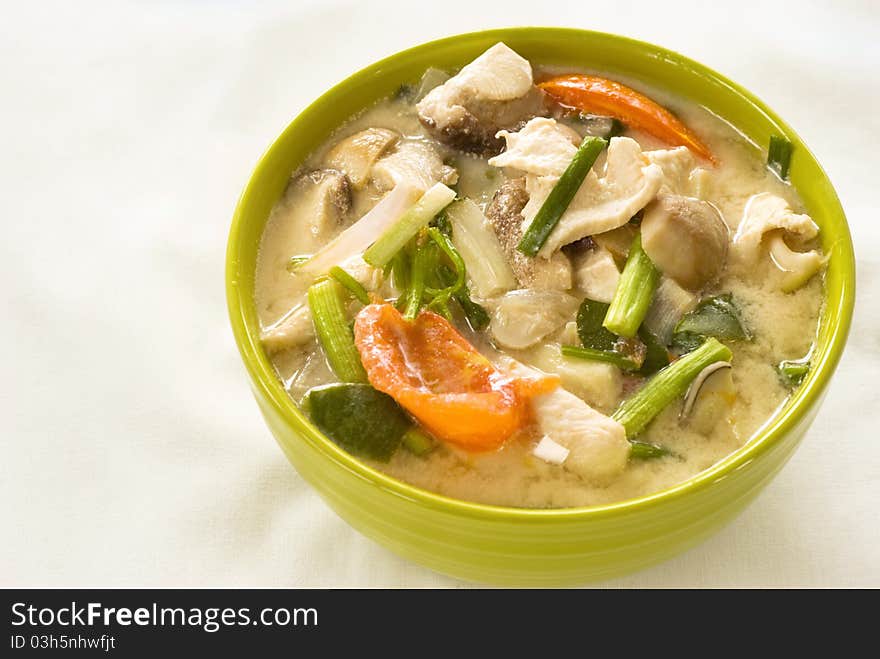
<box><xmin>516</xmin><ymin>135</ymin><xmax>608</xmax><ymax>256</ymax></box>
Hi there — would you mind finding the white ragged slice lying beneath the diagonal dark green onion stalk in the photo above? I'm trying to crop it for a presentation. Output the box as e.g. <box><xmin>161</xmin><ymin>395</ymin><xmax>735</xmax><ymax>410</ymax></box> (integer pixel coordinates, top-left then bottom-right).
<box><xmin>490</xmin><ymin>118</ymin><xmax>663</xmax><ymax>258</ymax></box>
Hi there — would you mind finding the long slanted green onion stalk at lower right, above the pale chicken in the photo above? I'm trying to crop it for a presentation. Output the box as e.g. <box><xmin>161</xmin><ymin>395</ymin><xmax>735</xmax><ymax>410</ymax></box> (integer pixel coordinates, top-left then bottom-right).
<box><xmin>612</xmin><ymin>337</ymin><xmax>733</xmax><ymax>438</ymax></box>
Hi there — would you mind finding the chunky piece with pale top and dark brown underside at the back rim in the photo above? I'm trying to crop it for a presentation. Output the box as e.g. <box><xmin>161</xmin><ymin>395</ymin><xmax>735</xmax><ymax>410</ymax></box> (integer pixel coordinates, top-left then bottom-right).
<box><xmin>416</xmin><ymin>43</ymin><xmax>546</xmax><ymax>153</ymax></box>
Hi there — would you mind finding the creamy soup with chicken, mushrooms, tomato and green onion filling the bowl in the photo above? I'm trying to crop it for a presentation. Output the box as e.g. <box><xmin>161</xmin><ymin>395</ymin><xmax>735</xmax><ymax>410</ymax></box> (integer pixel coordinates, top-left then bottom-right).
<box><xmin>256</xmin><ymin>44</ymin><xmax>825</xmax><ymax>508</ymax></box>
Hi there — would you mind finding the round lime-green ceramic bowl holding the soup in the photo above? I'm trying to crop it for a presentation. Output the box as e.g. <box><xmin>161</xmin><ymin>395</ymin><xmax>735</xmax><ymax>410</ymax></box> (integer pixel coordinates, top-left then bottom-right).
<box><xmin>226</xmin><ymin>28</ymin><xmax>855</xmax><ymax>586</ymax></box>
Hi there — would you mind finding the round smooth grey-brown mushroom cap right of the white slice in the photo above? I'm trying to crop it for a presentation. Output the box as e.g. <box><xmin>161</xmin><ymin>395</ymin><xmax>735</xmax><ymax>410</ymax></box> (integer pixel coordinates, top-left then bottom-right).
<box><xmin>642</xmin><ymin>195</ymin><xmax>729</xmax><ymax>291</ymax></box>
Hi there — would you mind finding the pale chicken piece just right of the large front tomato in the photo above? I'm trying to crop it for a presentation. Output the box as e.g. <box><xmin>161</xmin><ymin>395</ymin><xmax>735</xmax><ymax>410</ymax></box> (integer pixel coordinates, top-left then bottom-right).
<box><xmin>532</xmin><ymin>388</ymin><xmax>630</xmax><ymax>484</ymax></box>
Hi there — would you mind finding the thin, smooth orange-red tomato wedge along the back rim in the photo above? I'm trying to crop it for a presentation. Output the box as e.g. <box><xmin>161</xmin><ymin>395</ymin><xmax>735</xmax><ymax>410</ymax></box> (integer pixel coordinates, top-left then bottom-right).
<box><xmin>538</xmin><ymin>74</ymin><xmax>716</xmax><ymax>163</ymax></box>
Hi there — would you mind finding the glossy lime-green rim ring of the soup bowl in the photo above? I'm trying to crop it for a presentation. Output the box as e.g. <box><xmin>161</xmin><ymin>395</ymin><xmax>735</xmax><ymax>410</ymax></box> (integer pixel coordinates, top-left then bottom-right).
<box><xmin>226</xmin><ymin>27</ymin><xmax>855</xmax><ymax>523</ymax></box>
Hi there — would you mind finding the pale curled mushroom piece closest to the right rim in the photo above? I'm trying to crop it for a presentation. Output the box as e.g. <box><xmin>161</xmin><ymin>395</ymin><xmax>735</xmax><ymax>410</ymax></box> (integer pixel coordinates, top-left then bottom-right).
<box><xmin>733</xmin><ymin>192</ymin><xmax>825</xmax><ymax>292</ymax></box>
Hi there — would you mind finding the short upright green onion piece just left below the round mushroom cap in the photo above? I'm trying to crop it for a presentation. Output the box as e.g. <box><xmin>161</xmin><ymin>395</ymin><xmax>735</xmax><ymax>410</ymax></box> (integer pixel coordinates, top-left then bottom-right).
<box><xmin>602</xmin><ymin>234</ymin><xmax>660</xmax><ymax>339</ymax></box>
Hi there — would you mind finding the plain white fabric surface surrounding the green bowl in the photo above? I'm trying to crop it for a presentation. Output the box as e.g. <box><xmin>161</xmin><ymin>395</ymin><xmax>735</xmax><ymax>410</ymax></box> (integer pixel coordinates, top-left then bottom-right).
<box><xmin>0</xmin><ymin>0</ymin><xmax>880</xmax><ymax>587</ymax></box>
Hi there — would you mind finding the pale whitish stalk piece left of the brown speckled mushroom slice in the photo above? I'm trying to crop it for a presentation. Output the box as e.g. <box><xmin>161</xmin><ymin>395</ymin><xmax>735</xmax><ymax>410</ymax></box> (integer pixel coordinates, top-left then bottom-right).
<box><xmin>446</xmin><ymin>199</ymin><xmax>516</xmax><ymax>297</ymax></box>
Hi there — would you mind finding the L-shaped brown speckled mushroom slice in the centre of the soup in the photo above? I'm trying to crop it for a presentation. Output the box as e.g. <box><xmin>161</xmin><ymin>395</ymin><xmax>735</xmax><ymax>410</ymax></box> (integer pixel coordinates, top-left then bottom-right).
<box><xmin>486</xmin><ymin>178</ymin><xmax>571</xmax><ymax>290</ymax></box>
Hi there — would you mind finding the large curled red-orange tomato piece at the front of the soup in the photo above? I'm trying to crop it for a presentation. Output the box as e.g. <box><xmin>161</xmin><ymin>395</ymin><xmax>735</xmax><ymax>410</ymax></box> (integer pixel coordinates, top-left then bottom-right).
<box><xmin>354</xmin><ymin>304</ymin><xmax>558</xmax><ymax>452</ymax></box>
